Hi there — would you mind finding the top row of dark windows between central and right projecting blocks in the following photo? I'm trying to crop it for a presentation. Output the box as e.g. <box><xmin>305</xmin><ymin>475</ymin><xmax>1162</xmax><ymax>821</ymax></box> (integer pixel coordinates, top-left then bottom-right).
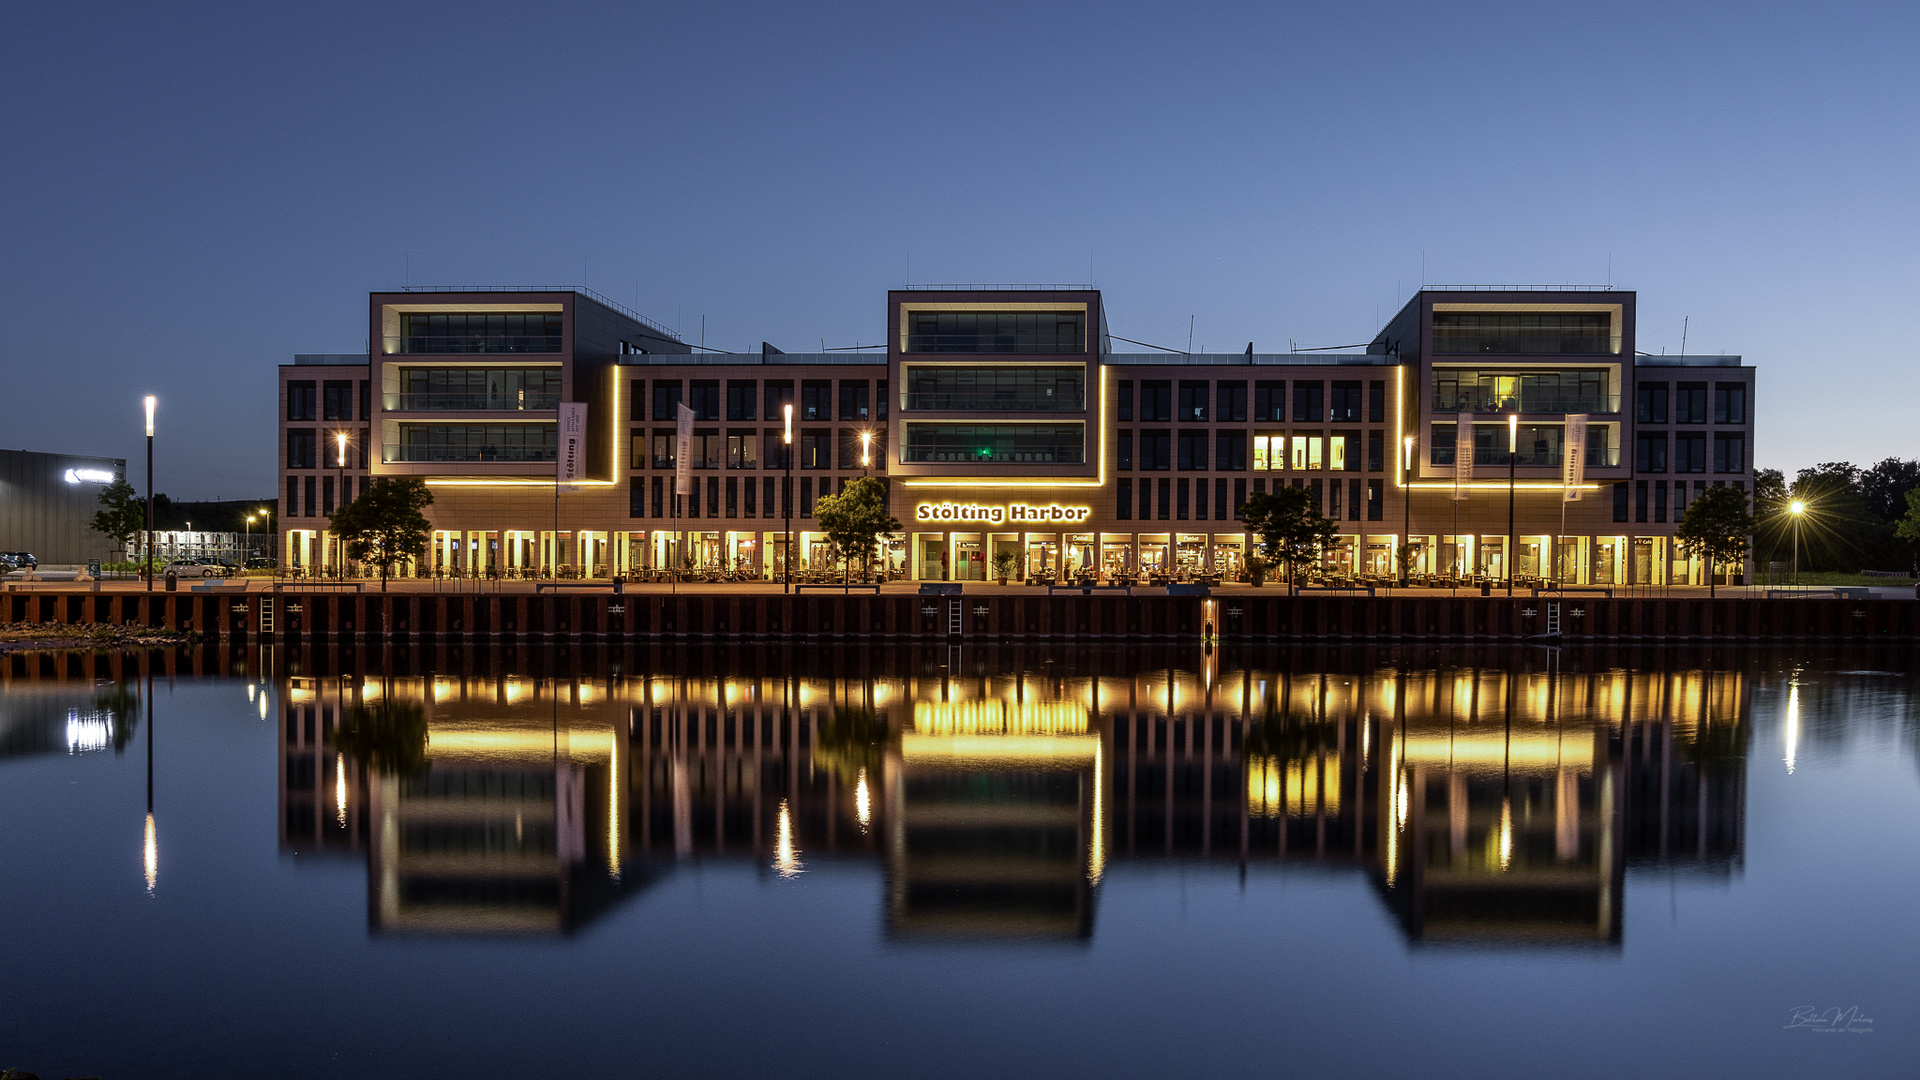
<box><xmin>1114</xmin><ymin>379</ymin><xmax>1386</xmax><ymax>423</ymax></box>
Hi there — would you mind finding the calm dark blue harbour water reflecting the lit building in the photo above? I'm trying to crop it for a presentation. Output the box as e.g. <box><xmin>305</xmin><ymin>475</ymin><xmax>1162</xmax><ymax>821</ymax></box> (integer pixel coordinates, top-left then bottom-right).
<box><xmin>0</xmin><ymin>648</ymin><xmax>1920</xmax><ymax>1080</ymax></box>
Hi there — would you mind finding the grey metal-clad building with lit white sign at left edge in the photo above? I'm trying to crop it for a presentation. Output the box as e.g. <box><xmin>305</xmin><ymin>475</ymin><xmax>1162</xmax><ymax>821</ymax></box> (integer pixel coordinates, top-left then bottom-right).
<box><xmin>0</xmin><ymin>450</ymin><xmax>127</xmax><ymax>565</ymax></box>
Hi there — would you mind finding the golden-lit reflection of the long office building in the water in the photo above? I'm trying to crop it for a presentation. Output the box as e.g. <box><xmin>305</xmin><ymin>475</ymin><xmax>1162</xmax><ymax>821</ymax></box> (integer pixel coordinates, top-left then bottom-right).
<box><xmin>280</xmin><ymin>650</ymin><xmax>1751</xmax><ymax>945</ymax></box>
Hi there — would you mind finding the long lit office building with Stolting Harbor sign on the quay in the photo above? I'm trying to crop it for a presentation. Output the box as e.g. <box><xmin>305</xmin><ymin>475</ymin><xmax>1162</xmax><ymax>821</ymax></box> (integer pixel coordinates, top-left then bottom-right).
<box><xmin>280</xmin><ymin>278</ymin><xmax>1755</xmax><ymax>584</ymax></box>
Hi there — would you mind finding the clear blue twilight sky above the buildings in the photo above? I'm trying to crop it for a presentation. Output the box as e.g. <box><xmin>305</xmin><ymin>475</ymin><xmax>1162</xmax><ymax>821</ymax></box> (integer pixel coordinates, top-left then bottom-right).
<box><xmin>0</xmin><ymin>0</ymin><xmax>1920</xmax><ymax>498</ymax></box>
